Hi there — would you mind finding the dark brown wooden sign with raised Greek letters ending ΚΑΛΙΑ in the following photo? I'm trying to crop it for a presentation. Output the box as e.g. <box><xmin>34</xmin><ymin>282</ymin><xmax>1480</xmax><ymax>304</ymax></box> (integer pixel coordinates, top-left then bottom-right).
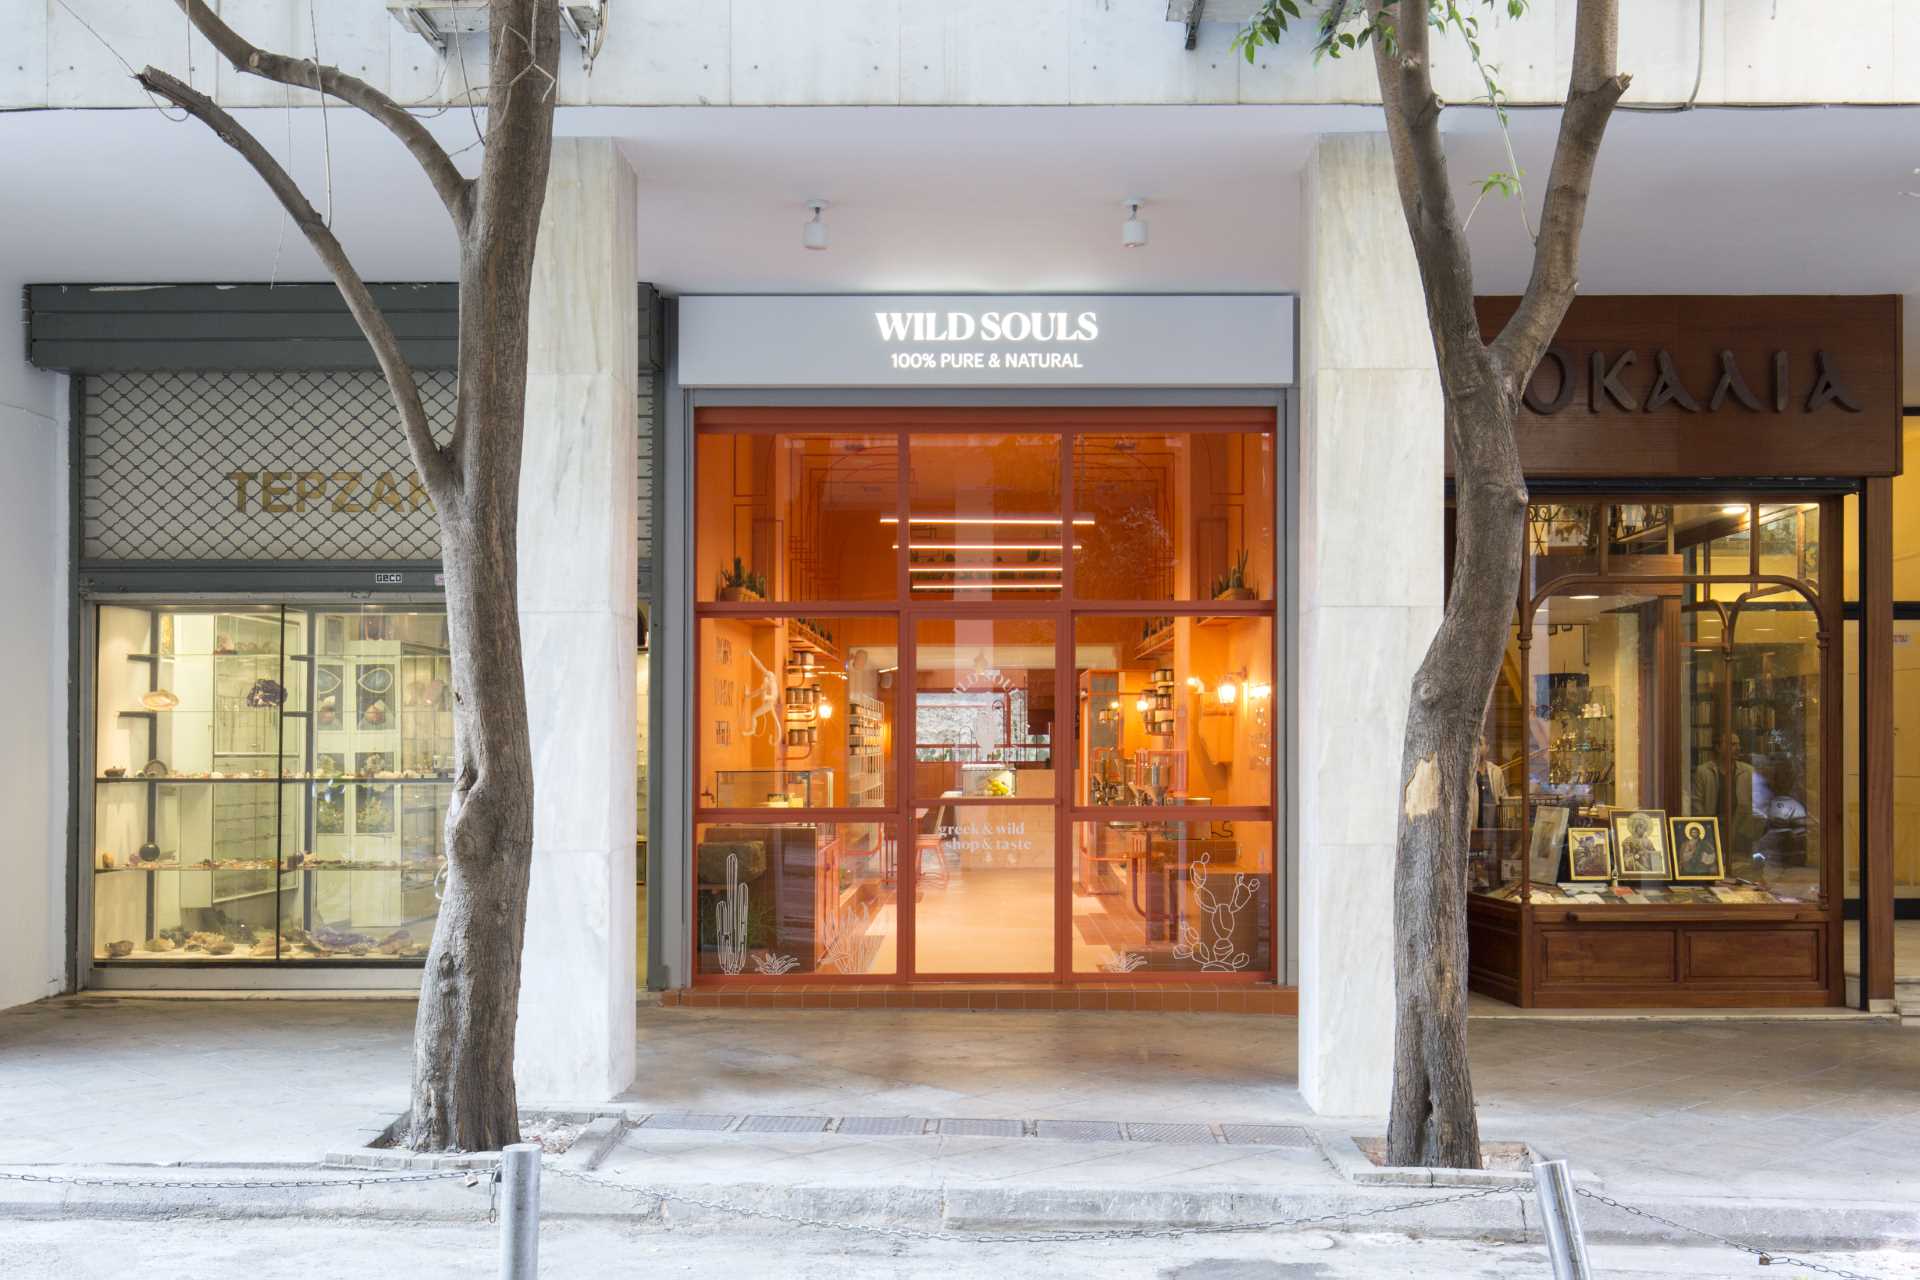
<box><xmin>1478</xmin><ymin>296</ymin><xmax>1901</xmax><ymax>482</ymax></box>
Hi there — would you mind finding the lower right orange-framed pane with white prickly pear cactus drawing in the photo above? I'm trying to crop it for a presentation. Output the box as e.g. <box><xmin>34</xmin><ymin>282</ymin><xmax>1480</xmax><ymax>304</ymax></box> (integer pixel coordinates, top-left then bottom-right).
<box><xmin>1073</xmin><ymin>819</ymin><xmax>1273</xmax><ymax>973</ymax></box>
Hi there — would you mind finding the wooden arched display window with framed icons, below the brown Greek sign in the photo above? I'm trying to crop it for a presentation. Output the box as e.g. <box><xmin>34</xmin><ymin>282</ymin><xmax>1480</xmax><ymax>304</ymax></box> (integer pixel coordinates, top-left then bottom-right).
<box><xmin>1467</xmin><ymin>499</ymin><xmax>1841</xmax><ymax>1007</ymax></box>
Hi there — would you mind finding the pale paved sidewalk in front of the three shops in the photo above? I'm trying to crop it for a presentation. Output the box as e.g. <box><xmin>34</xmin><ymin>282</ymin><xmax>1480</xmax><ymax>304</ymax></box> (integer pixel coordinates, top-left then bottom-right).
<box><xmin>0</xmin><ymin>998</ymin><xmax>1920</xmax><ymax>1244</ymax></box>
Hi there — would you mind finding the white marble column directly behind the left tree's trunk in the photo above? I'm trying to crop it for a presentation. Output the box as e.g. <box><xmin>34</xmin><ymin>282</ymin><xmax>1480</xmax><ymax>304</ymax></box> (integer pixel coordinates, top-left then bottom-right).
<box><xmin>513</xmin><ymin>138</ymin><xmax>639</xmax><ymax>1105</ymax></box>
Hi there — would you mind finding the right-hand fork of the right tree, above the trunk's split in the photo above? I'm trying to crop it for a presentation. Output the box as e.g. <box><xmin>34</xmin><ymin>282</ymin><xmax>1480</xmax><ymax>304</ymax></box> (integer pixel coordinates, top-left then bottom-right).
<box><xmin>1492</xmin><ymin>0</ymin><xmax>1632</xmax><ymax>378</ymax></box>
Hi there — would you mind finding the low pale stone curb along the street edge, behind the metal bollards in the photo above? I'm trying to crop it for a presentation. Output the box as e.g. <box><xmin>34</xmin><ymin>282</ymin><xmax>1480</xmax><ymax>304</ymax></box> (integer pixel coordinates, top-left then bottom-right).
<box><xmin>0</xmin><ymin>1159</ymin><xmax>1920</xmax><ymax>1251</ymax></box>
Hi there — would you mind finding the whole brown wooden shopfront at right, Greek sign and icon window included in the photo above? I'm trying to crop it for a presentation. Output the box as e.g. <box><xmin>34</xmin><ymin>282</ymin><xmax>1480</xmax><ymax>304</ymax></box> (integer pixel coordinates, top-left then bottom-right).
<box><xmin>1448</xmin><ymin>296</ymin><xmax>1901</xmax><ymax>1007</ymax></box>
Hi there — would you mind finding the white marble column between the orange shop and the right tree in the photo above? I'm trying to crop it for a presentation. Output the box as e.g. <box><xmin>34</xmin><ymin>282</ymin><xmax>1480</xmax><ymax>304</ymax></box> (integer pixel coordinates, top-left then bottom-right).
<box><xmin>1294</xmin><ymin>134</ymin><xmax>1444</xmax><ymax>1115</ymax></box>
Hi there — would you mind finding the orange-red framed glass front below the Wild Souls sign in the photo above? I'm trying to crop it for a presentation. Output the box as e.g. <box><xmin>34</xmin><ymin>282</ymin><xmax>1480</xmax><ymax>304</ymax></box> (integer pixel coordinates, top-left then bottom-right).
<box><xmin>691</xmin><ymin>407</ymin><xmax>1279</xmax><ymax>983</ymax></box>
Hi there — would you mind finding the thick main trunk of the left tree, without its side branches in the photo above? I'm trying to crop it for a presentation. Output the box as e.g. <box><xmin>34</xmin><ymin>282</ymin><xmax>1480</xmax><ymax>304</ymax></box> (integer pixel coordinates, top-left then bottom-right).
<box><xmin>409</xmin><ymin>0</ymin><xmax>559</xmax><ymax>1151</ymax></box>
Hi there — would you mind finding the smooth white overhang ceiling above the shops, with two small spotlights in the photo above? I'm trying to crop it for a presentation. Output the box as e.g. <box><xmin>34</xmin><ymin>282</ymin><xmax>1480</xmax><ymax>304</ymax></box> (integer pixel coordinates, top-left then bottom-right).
<box><xmin>0</xmin><ymin>106</ymin><xmax>1920</xmax><ymax>399</ymax></box>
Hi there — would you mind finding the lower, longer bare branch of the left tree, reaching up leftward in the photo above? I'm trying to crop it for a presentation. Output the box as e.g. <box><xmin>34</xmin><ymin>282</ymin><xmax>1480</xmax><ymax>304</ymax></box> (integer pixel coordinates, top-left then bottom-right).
<box><xmin>136</xmin><ymin>65</ymin><xmax>449</xmax><ymax>503</ymax></box>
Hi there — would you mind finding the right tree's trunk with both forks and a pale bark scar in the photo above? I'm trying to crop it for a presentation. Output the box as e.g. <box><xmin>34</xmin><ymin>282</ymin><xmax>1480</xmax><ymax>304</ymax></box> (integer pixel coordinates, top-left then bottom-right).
<box><xmin>1367</xmin><ymin>0</ymin><xmax>1628</xmax><ymax>1169</ymax></box>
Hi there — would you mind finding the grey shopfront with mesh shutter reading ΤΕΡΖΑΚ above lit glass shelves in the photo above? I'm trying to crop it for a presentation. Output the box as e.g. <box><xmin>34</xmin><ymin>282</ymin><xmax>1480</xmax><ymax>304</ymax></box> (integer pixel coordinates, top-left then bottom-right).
<box><xmin>29</xmin><ymin>284</ymin><xmax>657</xmax><ymax>988</ymax></box>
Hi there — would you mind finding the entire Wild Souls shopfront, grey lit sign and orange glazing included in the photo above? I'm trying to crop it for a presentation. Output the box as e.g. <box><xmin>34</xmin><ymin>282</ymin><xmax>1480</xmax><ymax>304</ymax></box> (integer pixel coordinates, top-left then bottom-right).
<box><xmin>653</xmin><ymin>296</ymin><xmax>1294</xmax><ymax>1009</ymax></box>
